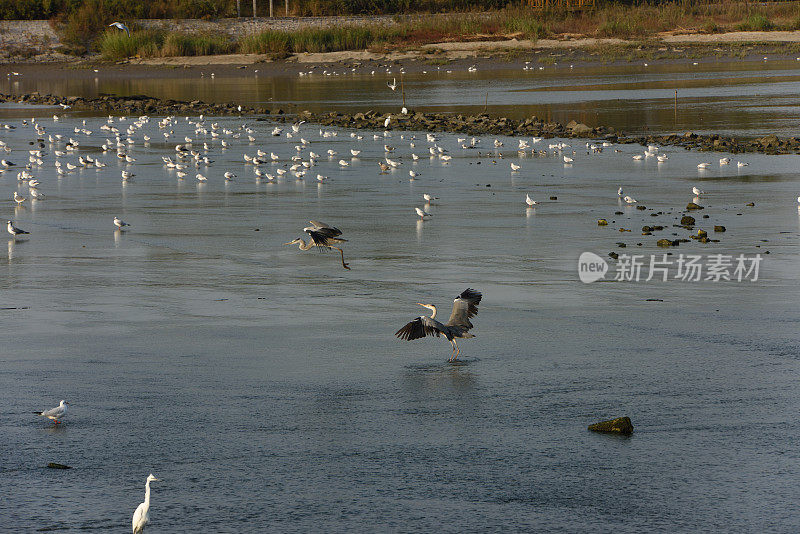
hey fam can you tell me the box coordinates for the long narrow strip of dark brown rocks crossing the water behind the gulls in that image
[0,92,800,154]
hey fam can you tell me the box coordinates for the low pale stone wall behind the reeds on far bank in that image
[0,15,396,60]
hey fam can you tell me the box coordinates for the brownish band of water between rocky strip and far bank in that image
[6,57,800,137]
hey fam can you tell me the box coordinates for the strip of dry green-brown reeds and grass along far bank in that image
[28,0,800,59]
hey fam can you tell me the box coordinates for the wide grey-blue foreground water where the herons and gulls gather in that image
[0,103,800,532]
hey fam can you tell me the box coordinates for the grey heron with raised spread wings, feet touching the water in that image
[395,288,482,362]
